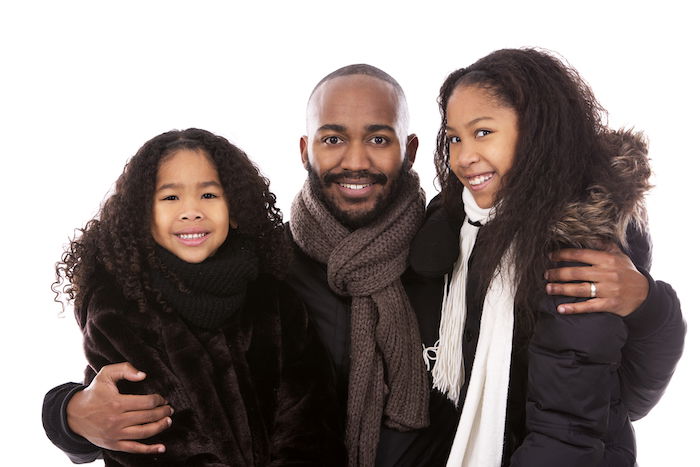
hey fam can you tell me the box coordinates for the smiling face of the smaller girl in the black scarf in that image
[151,149,231,263]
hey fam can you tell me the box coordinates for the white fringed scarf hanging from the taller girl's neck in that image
[433,188,515,467]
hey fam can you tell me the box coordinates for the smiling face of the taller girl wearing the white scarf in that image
[446,86,518,208]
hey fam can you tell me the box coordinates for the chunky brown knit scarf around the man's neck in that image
[290,171,429,467]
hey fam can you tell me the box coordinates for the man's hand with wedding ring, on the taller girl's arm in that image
[545,246,649,316]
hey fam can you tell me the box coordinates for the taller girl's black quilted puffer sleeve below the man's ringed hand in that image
[510,297,627,467]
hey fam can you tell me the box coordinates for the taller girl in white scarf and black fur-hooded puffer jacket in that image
[411,49,685,467]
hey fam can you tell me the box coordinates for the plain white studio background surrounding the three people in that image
[0,0,700,466]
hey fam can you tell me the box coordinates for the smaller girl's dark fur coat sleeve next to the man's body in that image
[270,284,347,466]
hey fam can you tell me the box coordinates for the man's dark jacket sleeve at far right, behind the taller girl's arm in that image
[620,270,686,420]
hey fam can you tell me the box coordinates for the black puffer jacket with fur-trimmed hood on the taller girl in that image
[410,133,685,467]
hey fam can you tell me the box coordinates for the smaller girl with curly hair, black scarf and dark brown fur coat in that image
[57,129,344,466]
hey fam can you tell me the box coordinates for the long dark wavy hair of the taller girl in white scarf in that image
[435,49,615,331]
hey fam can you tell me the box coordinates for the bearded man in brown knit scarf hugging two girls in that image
[43,65,671,466]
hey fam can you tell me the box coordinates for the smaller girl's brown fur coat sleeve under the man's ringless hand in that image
[83,294,230,466]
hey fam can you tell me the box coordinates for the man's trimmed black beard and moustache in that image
[306,158,409,230]
